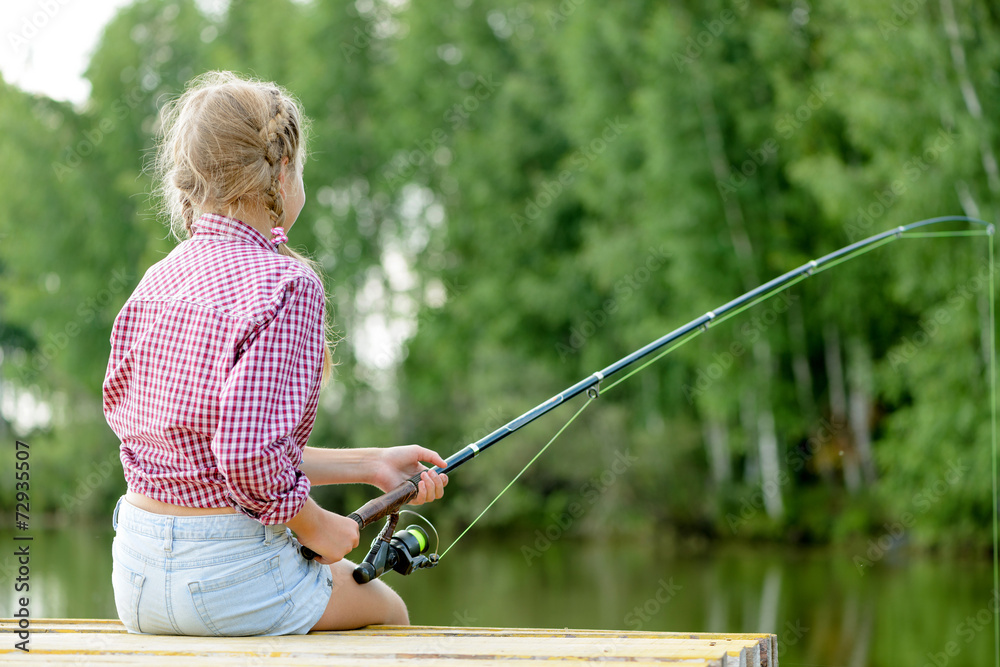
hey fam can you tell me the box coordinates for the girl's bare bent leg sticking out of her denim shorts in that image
[312,559,410,630]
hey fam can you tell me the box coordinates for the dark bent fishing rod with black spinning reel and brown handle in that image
[301,216,994,583]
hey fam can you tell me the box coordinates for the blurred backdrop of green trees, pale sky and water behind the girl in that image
[0,0,1000,667]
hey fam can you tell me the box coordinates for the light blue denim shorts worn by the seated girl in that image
[111,497,333,636]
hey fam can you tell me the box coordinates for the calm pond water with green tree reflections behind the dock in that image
[0,529,994,667]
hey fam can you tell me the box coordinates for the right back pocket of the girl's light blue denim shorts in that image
[188,556,293,636]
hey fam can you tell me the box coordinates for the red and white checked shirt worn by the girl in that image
[104,215,326,524]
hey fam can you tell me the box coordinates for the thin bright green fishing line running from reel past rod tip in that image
[428,222,1000,580]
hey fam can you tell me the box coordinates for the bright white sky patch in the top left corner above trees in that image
[0,0,160,103]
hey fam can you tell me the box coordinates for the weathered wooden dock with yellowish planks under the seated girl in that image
[0,618,778,667]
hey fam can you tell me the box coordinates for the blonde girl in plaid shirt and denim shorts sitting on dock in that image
[104,72,447,635]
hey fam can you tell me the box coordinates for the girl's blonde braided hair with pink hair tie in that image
[154,72,335,382]
